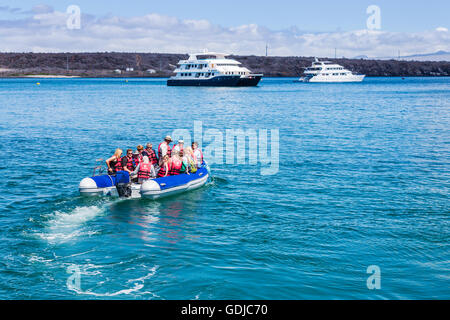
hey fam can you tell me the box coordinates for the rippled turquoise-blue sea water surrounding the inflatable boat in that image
[0,78,450,299]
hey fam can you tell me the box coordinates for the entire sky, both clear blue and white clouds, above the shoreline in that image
[0,0,450,57]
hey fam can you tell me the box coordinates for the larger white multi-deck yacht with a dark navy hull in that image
[167,52,263,87]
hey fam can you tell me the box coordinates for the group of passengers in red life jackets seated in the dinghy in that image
[106,136,203,183]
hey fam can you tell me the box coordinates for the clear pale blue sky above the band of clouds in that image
[0,0,450,32]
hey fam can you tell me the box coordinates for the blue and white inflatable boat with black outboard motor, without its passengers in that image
[79,165,209,199]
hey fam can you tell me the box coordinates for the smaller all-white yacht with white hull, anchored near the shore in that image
[299,58,365,82]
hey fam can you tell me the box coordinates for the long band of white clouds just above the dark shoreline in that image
[0,6,450,57]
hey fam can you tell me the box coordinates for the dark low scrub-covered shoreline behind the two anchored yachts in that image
[0,52,450,77]
